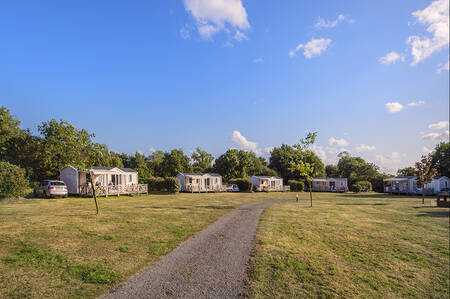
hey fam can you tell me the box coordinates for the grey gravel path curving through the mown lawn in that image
[103,200,286,298]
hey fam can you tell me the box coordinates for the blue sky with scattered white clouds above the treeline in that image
[0,0,449,172]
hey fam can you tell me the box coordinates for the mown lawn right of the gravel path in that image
[245,193,450,298]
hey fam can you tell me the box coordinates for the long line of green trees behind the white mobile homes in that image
[0,107,449,191]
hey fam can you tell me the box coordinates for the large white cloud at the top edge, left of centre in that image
[183,0,250,40]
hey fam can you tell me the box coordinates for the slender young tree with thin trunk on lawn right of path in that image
[289,132,323,207]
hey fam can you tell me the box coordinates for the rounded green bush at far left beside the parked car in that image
[0,162,28,198]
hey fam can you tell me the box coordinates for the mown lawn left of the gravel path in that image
[0,193,293,298]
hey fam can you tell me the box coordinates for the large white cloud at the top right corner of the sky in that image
[407,0,449,66]
